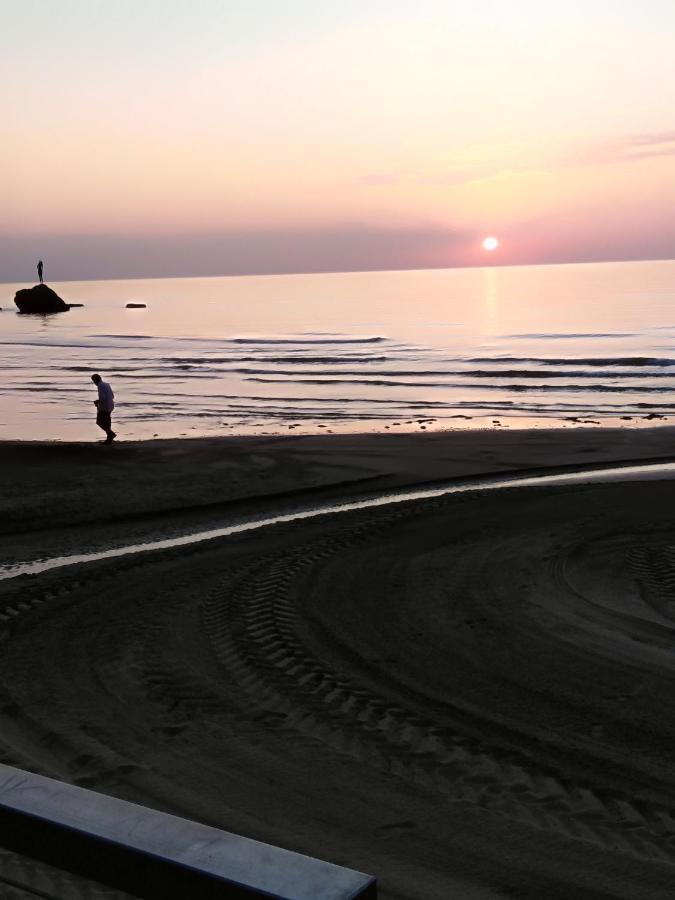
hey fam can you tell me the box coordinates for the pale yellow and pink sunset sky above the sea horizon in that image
[0,0,675,281]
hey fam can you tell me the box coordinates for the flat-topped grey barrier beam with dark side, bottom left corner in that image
[0,764,377,900]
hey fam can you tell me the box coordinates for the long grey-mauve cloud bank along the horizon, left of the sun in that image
[0,223,473,282]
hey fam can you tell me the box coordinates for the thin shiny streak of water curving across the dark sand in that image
[0,463,675,580]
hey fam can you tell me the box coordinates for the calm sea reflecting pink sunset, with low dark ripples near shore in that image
[0,262,675,440]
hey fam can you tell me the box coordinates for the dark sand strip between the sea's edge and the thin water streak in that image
[0,425,675,535]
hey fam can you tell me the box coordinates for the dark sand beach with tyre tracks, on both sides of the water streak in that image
[0,427,675,900]
